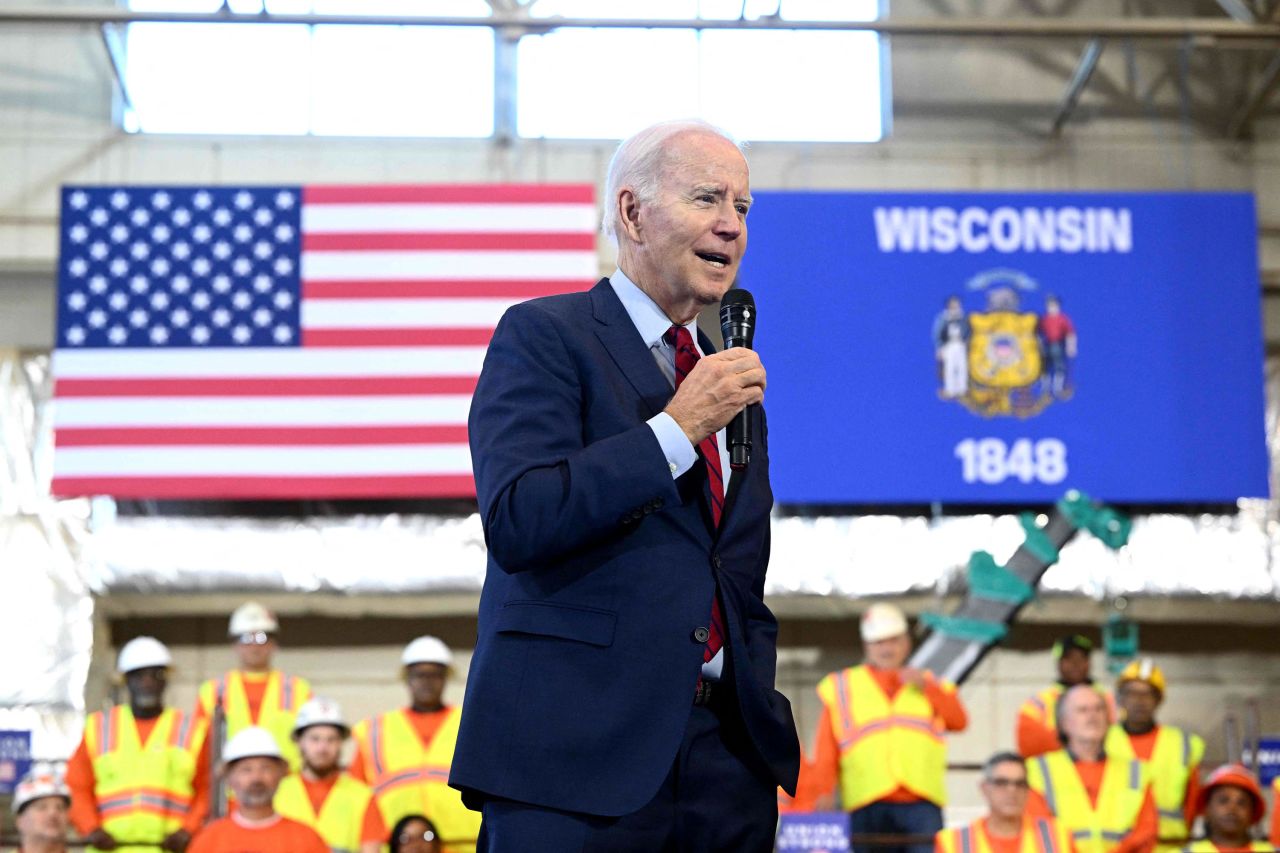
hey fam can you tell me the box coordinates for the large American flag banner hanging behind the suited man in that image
[52,184,598,500]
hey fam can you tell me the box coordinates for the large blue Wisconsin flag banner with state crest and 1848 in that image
[741,192,1267,503]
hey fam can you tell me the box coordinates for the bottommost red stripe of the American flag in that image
[52,474,476,500]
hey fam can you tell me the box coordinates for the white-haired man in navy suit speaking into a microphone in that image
[449,122,799,853]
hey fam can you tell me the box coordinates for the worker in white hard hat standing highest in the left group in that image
[196,601,311,770]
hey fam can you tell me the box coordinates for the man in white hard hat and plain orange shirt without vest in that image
[189,726,330,853]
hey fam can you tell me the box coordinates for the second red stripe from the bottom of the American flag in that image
[54,424,467,447]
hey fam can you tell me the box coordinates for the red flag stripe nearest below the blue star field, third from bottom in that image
[54,377,476,397]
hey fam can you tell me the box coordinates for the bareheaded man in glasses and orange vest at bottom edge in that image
[934,752,1075,853]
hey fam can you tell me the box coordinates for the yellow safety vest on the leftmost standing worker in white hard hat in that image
[84,706,205,853]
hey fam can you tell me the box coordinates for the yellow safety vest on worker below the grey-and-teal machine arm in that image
[818,665,947,811]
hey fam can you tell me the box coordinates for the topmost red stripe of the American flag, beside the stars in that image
[302,183,595,205]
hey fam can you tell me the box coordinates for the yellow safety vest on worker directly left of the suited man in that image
[351,708,480,853]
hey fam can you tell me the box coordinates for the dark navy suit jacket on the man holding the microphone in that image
[449,279,799,816]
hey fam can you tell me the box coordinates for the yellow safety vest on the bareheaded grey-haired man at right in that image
[1027,749,1151,853]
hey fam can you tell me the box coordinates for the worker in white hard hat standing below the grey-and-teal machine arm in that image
[810,603,969,853]
